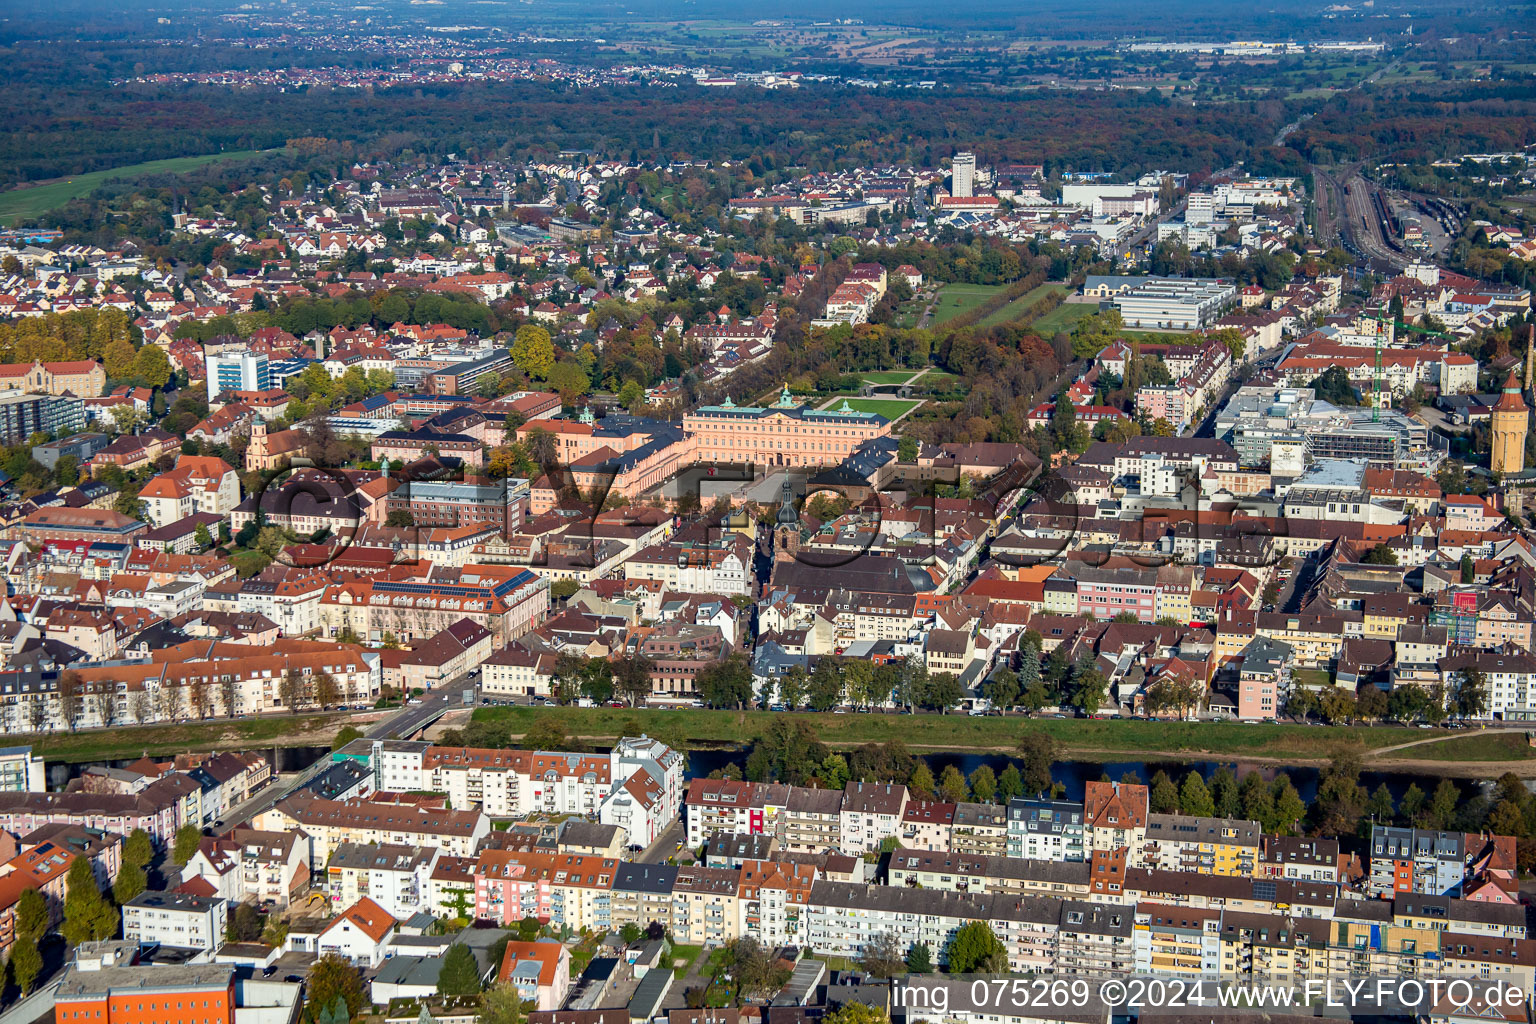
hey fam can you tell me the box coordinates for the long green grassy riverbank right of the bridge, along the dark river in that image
[475,708,1510,761]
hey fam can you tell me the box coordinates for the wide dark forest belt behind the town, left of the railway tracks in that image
[0,81,1286,181]
